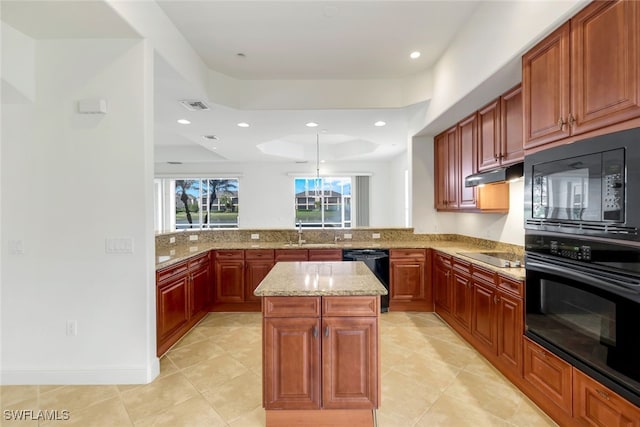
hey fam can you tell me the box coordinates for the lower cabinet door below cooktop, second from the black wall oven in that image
[471,280,497,354]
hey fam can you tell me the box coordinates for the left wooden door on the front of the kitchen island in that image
[263,317,321,409]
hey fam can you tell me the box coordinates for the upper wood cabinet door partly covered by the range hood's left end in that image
[458,113,478,209]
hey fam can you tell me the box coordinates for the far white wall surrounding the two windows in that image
[155,161,406,228]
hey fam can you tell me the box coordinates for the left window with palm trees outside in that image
[156,178,239,230]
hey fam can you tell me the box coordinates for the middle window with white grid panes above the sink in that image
[294,177,351,228]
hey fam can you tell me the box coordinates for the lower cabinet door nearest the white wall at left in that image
[156,274,190,347]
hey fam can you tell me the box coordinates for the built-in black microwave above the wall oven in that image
[524,128,640,241]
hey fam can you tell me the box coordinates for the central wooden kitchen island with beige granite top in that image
[255,261,387,427]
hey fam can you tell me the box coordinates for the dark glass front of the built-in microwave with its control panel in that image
[532,149,624,222]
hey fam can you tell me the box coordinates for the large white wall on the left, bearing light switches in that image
[0,39,159,384]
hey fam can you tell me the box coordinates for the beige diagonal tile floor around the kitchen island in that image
[0,312,555,427]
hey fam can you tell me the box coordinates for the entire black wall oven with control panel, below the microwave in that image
[525,236,640,406]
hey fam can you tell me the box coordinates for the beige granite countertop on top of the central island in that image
[254,261,387,297]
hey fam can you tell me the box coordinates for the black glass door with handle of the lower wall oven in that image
[526,255,640,402]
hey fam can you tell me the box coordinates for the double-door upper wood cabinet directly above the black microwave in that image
[522,0,640,149]
